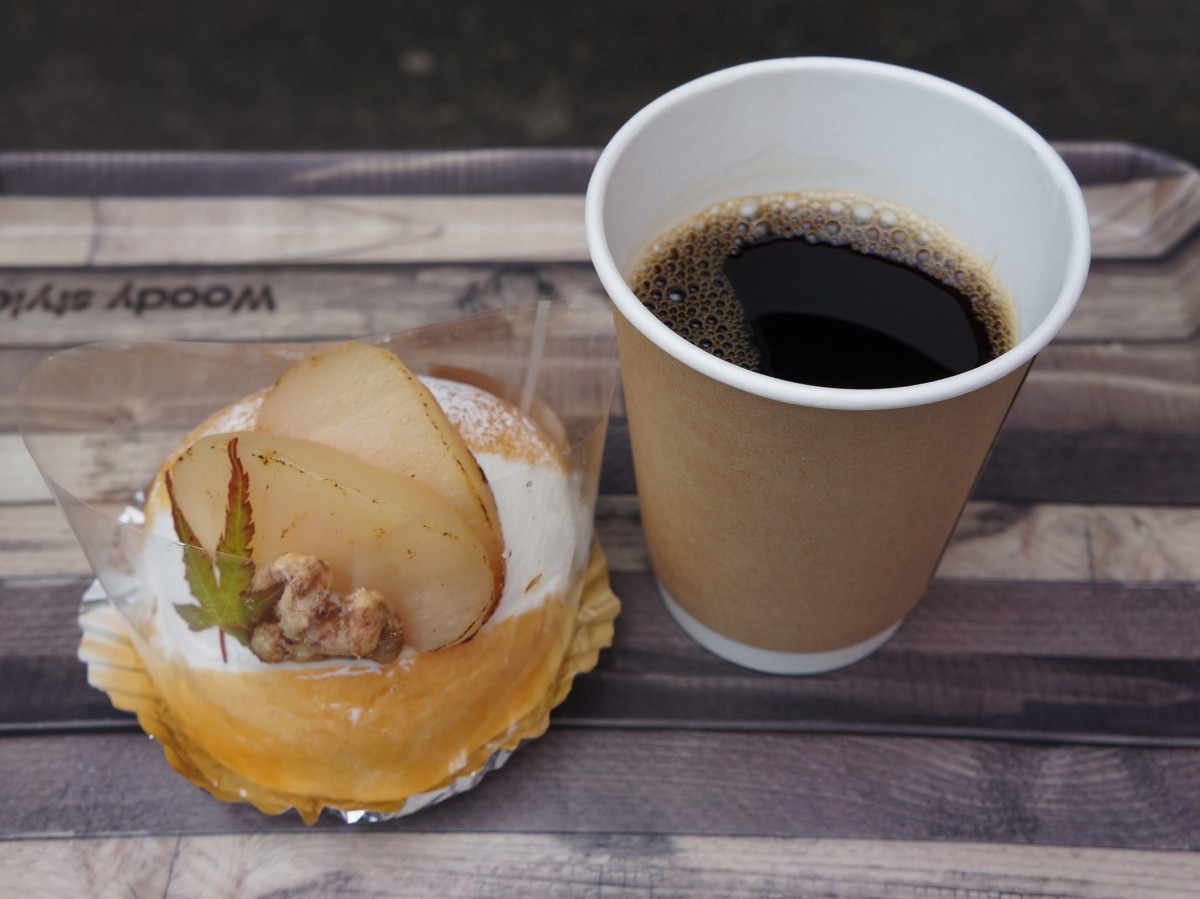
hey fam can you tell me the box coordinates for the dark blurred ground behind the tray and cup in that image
[0,0,1200,163]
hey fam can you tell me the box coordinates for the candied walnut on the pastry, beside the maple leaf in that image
[250,552,403,663]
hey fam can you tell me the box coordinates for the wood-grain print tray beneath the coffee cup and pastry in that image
[0,144,1200,897]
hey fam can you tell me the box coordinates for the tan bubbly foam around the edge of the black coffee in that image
[629,190,1016,371]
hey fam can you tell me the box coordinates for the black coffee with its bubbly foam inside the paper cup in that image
[630,191,1015,388]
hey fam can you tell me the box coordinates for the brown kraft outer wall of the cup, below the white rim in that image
[616,313,1028,653]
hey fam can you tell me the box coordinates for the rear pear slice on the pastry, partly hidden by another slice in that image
[256,343,504,587]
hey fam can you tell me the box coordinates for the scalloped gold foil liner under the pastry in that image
[79,539,620,825]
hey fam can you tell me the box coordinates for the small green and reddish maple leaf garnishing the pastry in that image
[166,437,284,661]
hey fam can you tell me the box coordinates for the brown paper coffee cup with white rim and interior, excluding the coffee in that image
[586,58,1090,673]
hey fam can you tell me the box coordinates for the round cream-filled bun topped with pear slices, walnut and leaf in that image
[100,343,616,821]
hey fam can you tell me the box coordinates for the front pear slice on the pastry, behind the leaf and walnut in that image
[172,431,498,652]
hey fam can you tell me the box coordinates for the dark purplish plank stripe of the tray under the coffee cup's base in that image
[0,573,1200,748]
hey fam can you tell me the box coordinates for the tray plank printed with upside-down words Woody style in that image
[0,250,1200,346]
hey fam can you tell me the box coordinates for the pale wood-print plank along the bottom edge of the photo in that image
[0,833,1200,899]
